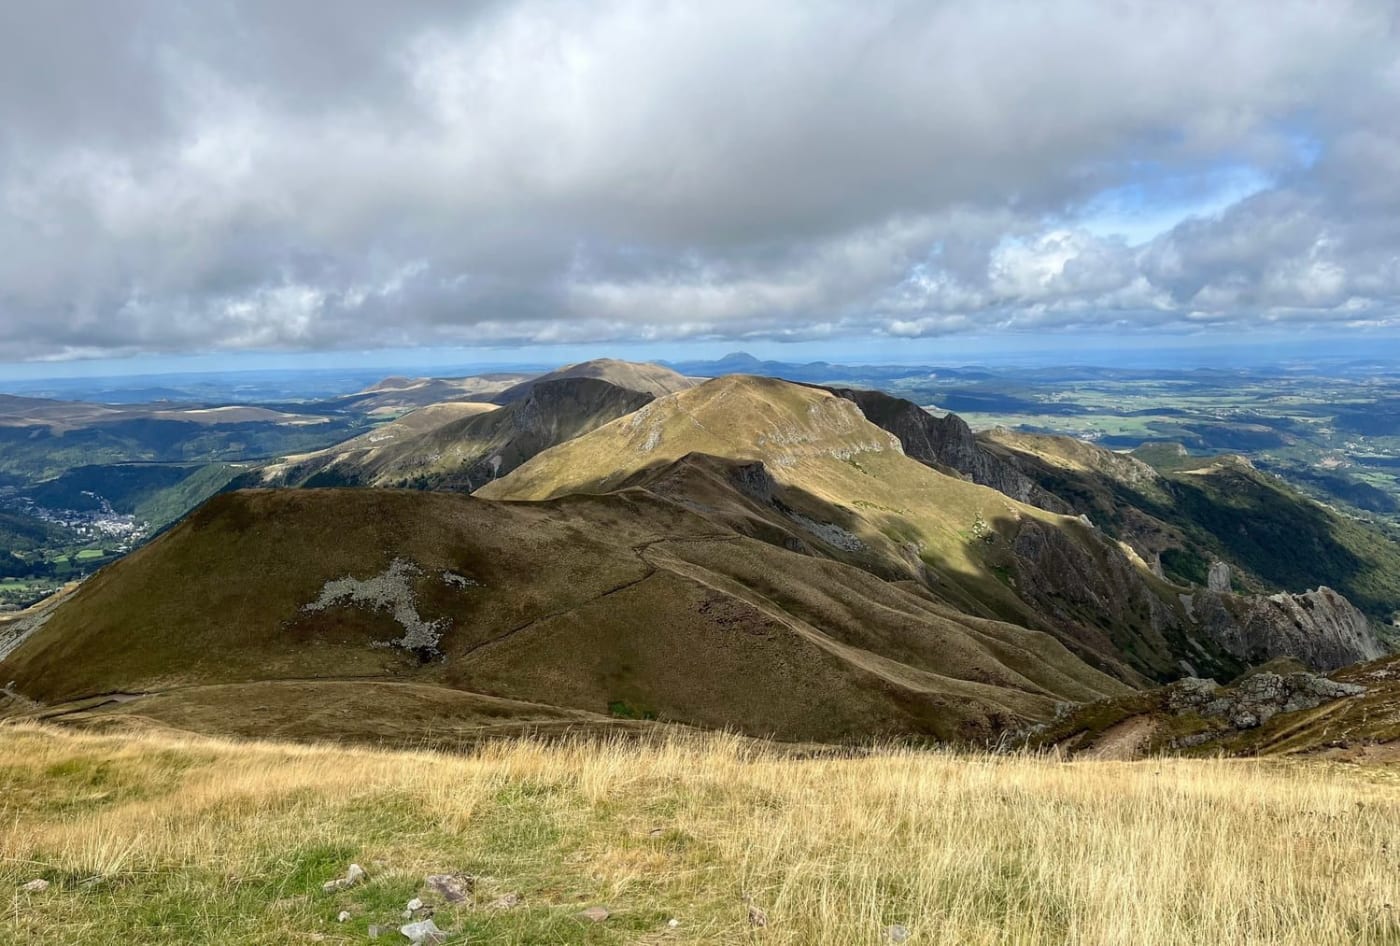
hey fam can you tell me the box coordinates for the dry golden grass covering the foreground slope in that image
[0,726,1400,946]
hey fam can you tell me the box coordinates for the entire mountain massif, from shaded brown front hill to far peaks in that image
[0,355,1400,742]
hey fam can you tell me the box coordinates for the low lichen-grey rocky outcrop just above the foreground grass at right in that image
[1166,673,1366,736]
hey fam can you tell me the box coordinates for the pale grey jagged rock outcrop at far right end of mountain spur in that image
[1187,588,1386,670]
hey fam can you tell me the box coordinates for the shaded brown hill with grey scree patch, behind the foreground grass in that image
[0,490,1126,740]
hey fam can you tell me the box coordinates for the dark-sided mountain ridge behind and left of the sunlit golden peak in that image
[259,376,652,493]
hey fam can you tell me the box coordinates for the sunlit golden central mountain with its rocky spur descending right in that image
[479,375,1379,684]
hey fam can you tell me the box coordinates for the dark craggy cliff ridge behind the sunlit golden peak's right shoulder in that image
[827,388,1070,512]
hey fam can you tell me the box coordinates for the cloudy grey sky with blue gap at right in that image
[0,0,1400,375]
